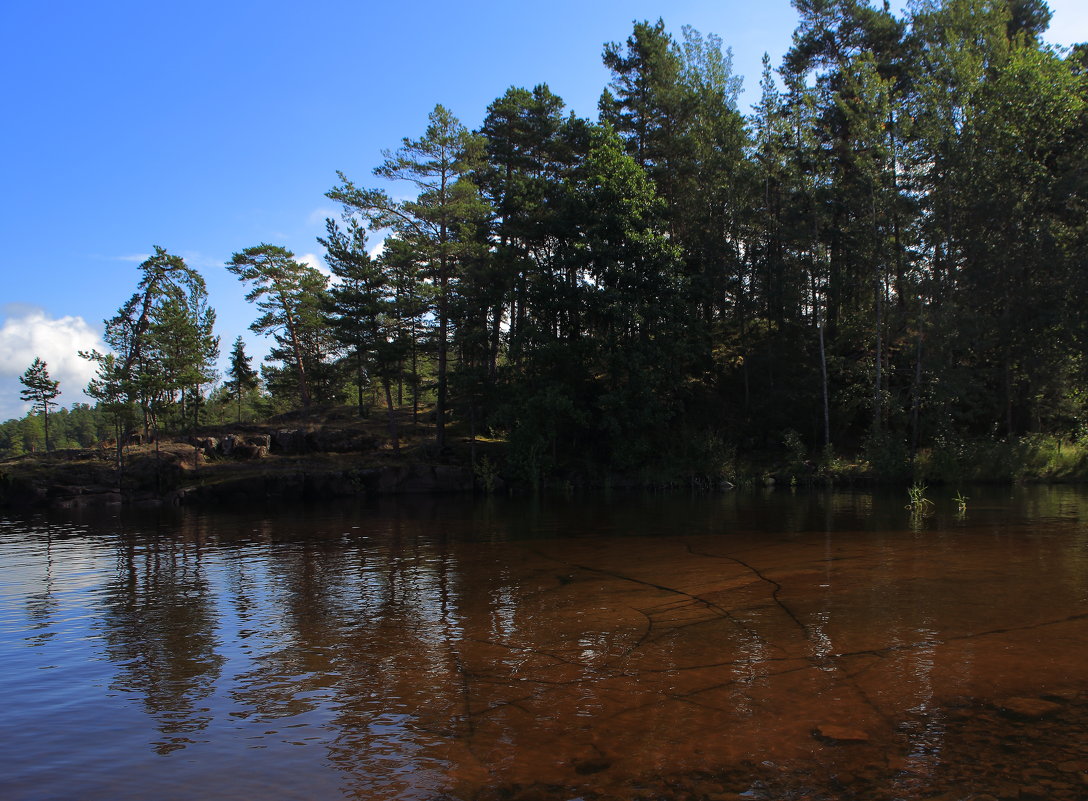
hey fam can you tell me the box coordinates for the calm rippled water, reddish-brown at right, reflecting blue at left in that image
[0,488,1088,801]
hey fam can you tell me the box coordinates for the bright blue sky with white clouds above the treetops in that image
[0,0,1088,420]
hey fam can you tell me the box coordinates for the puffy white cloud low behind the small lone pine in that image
[0,304,107,420]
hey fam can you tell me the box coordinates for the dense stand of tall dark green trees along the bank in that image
[0,0,1088,480]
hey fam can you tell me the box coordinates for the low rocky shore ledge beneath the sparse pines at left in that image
[0,428,485,508]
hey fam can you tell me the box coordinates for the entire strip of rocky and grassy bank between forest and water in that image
[0,406,1088,508]
